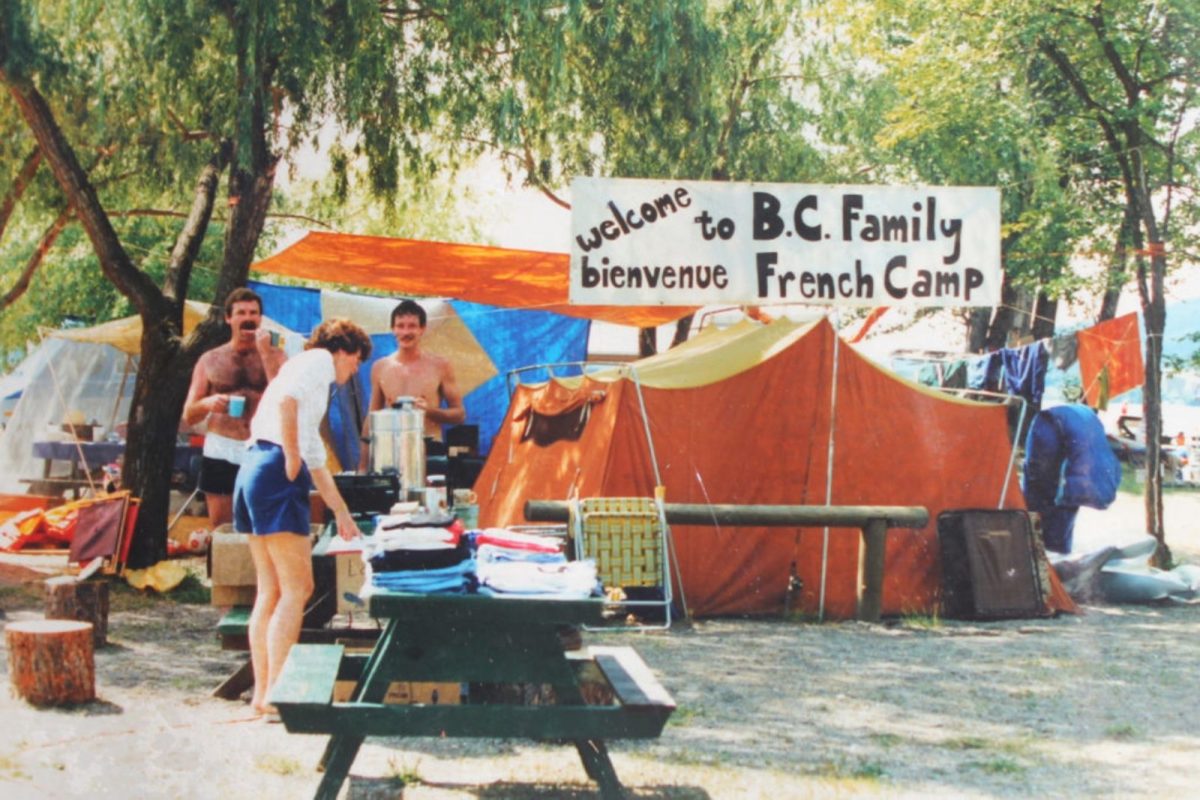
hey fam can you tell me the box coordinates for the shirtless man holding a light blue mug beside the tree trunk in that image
[184,288,287,528]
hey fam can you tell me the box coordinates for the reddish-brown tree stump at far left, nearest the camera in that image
[4,619,96,705]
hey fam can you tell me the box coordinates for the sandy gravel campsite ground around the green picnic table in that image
[0,494,1200,800]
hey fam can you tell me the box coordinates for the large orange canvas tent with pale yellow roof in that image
[475,319,1073,619]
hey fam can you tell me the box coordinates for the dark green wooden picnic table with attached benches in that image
[268,591,676,800]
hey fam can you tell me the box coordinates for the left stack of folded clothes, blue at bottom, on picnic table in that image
[362,512,475,594]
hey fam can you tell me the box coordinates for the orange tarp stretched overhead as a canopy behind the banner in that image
[253,231,695,327]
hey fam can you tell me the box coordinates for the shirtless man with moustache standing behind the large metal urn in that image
[359,300,467,471]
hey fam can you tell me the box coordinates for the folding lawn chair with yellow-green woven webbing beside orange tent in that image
[570,498,672,630]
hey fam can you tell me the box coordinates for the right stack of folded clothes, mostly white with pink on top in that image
[473,529,602,600]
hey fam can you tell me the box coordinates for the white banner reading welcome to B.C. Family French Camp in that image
[570,178,1001,306]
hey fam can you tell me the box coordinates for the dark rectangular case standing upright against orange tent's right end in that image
[937,509,1044,620]
